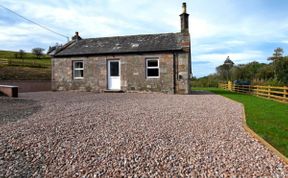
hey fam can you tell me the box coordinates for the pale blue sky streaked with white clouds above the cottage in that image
[0,0,288,77]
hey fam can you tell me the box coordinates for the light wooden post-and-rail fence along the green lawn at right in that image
[218,82,288,103]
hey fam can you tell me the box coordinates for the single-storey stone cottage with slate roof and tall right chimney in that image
[52,3,191,94]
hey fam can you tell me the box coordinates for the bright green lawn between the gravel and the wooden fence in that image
[193,88,288,157]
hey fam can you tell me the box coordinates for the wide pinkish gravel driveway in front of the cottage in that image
[0,92,288,177]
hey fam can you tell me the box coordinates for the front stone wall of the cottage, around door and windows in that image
[52,53,173,93]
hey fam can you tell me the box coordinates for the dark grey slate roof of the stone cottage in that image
[55,33,182,57]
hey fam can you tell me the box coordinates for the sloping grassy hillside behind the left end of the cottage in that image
[0,51,51,80]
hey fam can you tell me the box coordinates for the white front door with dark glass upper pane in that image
[108,60,121,90]
